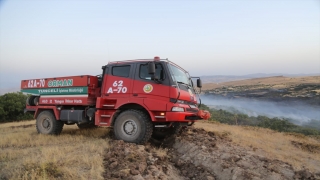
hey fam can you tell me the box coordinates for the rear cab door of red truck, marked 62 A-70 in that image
[102,64,134,98]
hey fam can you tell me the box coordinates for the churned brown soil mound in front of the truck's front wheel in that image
[104,127,320,180]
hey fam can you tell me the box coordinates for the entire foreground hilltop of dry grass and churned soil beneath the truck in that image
[0,120,320,180]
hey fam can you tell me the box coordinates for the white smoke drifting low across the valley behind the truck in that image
[201,95,320,125]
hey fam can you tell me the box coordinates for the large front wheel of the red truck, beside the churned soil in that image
[113,110,153,144]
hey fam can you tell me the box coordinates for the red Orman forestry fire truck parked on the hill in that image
[21,57,210,144]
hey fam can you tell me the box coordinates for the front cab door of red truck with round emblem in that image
[132,62,169,111]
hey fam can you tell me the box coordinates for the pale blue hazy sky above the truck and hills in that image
[0,0,320,88]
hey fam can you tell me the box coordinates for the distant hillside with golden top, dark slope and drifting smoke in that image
[202,76,320,126]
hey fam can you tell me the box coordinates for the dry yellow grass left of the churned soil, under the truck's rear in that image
[0,121,108,179]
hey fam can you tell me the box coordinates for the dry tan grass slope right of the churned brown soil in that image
[195,122,320,172]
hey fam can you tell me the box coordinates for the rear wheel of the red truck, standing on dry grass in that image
[36,111,64,135]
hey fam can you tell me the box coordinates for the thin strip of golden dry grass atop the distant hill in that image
[202,76,320,90]
